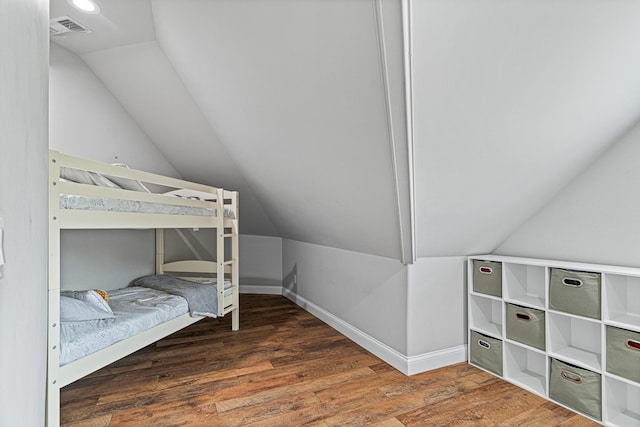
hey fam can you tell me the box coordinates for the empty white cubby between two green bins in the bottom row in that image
[504,342,548,397]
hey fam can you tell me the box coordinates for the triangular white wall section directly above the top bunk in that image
[49,44,180,178]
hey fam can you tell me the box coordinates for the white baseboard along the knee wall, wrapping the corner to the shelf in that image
[282,288,467,375]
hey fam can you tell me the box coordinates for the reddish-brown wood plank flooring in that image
[61,295,597,427]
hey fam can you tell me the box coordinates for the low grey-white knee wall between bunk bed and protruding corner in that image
[282,239,407,355]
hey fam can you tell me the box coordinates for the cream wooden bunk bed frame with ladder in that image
[46,150,239,427]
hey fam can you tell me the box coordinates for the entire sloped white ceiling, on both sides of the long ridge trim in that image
[51,0,640,260]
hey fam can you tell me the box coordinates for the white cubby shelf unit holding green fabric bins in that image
[467,255,640,427]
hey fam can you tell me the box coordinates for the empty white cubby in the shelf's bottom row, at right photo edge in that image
[605,376,640,427]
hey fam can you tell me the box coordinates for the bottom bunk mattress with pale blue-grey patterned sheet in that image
[60,286,189,366]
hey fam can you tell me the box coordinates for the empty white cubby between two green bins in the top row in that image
[503,262,546,309]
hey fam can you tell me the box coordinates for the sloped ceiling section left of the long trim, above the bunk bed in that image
[51,0,403,258]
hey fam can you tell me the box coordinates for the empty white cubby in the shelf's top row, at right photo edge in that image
[604,274,640,331]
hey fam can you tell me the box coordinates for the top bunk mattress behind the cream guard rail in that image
[60,194,234,218]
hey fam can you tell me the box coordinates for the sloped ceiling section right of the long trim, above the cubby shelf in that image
[412,0,640,256]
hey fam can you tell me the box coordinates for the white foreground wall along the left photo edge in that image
[0,0,49,426]
